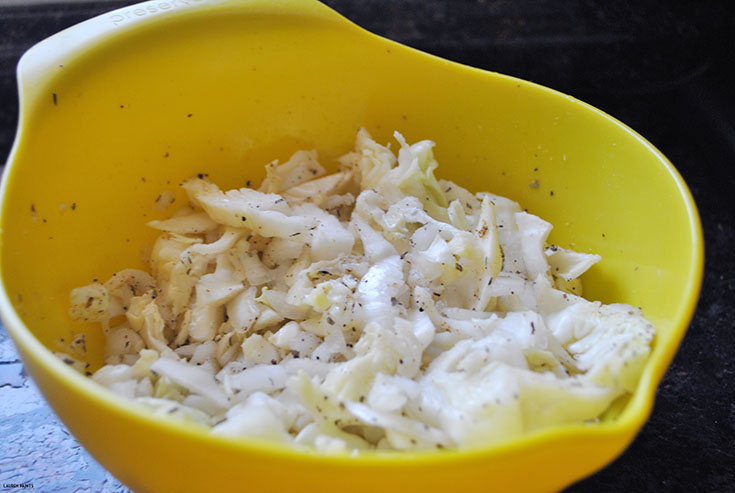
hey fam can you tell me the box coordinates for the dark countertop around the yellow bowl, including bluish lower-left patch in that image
[0,0,735,492]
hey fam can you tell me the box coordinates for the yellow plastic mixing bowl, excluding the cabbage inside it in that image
[0,0,703,491]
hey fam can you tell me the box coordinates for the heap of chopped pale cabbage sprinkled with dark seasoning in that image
[66,129,655,453]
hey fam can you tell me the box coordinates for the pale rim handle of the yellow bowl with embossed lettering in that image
[17,0,357,108]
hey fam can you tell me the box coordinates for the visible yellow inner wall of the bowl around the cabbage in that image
[0,1,702,490]
